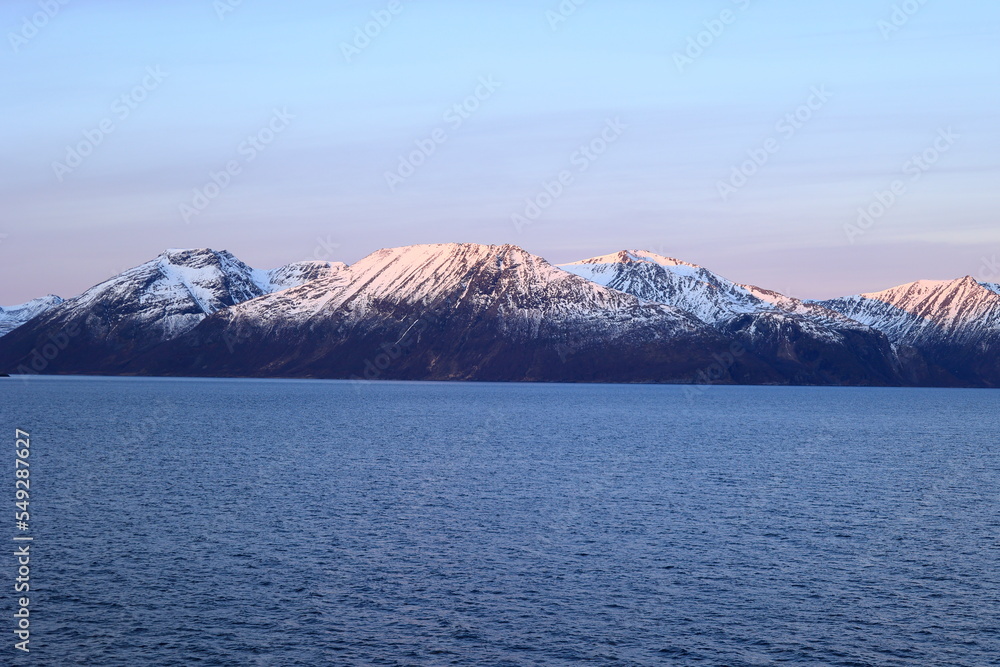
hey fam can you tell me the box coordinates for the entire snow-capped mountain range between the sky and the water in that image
[0,243,1000,387]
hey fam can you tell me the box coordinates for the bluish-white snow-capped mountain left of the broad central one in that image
[2,248,344,372]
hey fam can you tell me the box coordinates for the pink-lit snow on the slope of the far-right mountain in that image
[819,276,1000,345]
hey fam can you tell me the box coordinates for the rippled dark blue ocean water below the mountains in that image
[0,378,1000,666]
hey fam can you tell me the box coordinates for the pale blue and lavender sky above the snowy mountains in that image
[0,0,1000,304]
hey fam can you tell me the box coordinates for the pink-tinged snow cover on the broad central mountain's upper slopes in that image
[231,243,701,332]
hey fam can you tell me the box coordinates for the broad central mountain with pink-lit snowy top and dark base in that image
[125,243,766,381]
